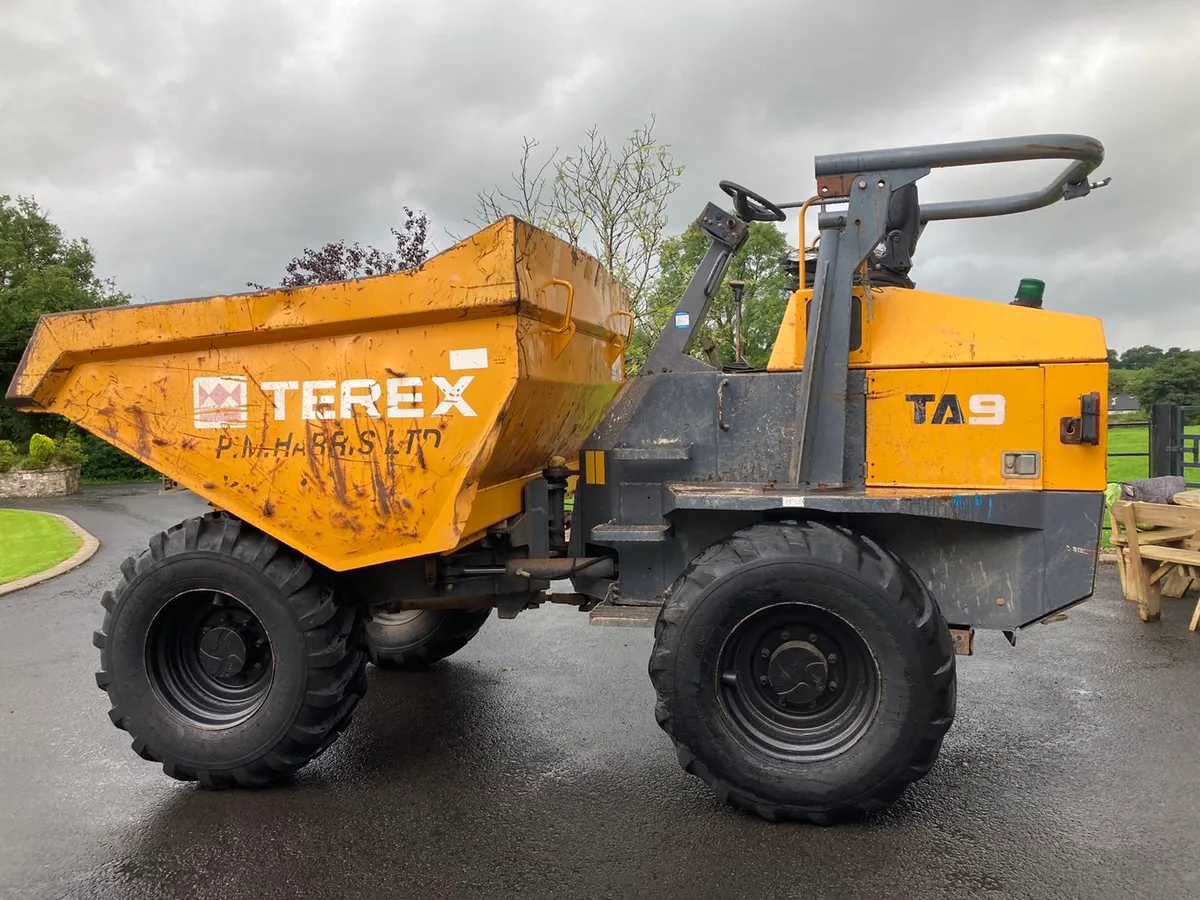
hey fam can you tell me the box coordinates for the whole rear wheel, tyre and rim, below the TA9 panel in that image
[649,522,955,824]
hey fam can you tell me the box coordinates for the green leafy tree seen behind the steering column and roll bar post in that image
[629,222,788,371]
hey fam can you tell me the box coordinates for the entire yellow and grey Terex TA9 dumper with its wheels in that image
[7,134,1108,823]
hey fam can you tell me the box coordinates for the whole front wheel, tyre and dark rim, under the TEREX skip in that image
[94,512,367,787]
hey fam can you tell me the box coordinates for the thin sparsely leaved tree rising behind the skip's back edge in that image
[475,115,683,336]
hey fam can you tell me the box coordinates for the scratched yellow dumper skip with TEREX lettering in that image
[7,218,632,571]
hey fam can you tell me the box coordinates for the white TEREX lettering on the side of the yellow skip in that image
[260,376,476,421]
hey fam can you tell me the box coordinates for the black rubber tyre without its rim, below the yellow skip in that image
[92,512,367,788]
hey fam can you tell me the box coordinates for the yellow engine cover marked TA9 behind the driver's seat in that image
[769,288,1108,491]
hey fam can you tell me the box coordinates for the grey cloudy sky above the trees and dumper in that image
[0,0,1200,349]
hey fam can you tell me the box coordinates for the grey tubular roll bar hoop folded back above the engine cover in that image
[816,134,1106,222]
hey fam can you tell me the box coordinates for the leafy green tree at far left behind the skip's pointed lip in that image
[0,194,152,478]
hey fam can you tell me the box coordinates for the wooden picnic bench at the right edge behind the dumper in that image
[1109,500,1200,631]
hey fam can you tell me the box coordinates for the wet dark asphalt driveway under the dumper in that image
[0,486,1200,900]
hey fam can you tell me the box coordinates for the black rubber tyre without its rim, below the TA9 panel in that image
[649,522,956,824]
